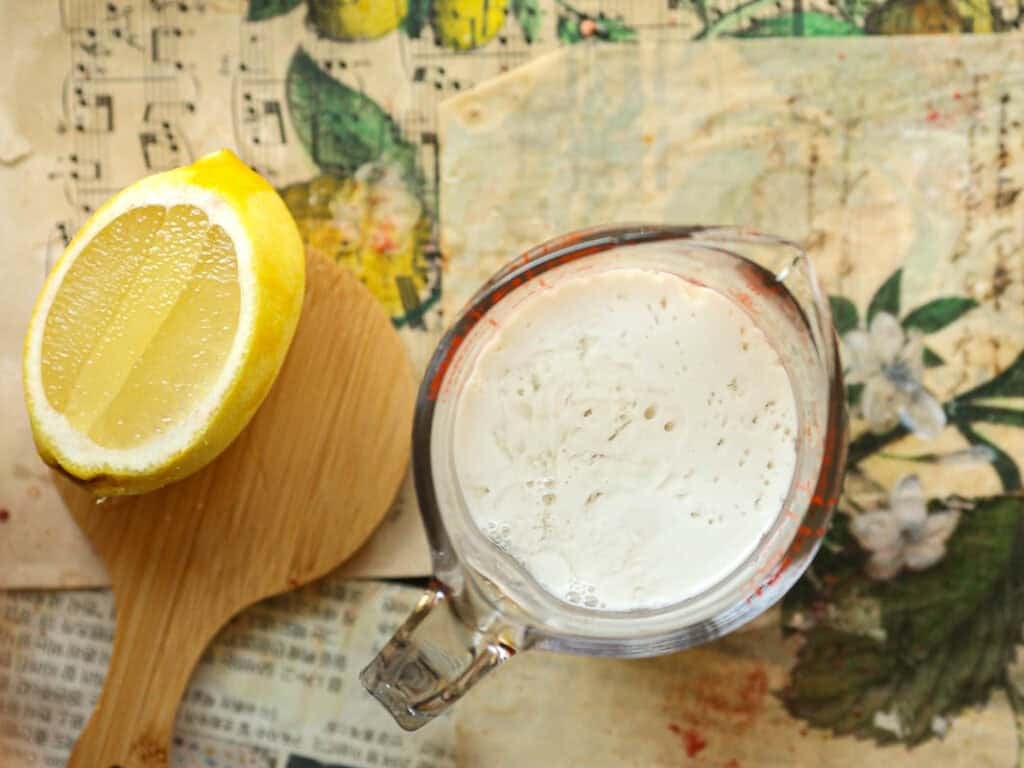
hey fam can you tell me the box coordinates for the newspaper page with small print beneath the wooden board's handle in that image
[0,579,456,768]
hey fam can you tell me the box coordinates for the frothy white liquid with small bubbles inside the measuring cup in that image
[454,268,797,611]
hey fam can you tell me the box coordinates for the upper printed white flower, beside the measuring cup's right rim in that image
[843,312,946,438]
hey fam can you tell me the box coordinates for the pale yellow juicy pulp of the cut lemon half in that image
[41,205,240,449]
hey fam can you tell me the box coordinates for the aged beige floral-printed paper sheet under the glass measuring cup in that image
[440,38,1024,766]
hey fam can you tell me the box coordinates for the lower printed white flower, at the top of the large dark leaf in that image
[850,475,959,581]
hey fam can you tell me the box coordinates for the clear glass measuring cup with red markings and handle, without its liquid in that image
[360,225,847,730]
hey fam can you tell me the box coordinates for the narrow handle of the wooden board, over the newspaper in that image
[68,585,228,768]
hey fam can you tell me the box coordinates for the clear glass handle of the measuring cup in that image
[359,581,515,731]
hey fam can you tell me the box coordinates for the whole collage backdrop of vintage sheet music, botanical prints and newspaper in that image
[0,0,1024,768]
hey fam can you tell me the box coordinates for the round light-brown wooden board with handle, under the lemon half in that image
[59,257,415,768]
